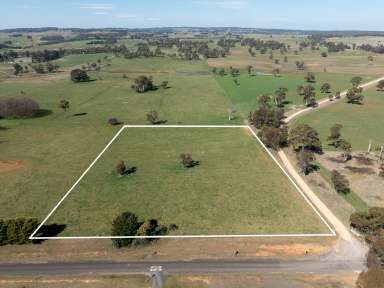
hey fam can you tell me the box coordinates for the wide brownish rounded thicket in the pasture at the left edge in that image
[0,97,40,119]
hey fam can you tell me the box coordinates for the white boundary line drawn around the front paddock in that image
[29,125,336,240]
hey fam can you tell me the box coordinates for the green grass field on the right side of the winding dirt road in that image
[296,89,384,151]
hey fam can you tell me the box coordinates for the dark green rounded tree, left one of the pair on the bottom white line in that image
[111,212,140,248]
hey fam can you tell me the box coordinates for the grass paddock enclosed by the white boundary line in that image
[43,128,327,236]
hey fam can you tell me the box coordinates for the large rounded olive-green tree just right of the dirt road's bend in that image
[288,124,322,152]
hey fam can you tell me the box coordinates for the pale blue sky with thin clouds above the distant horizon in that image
[0,0,384,31]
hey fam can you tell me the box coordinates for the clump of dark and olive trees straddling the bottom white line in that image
[111,212,171,248]
